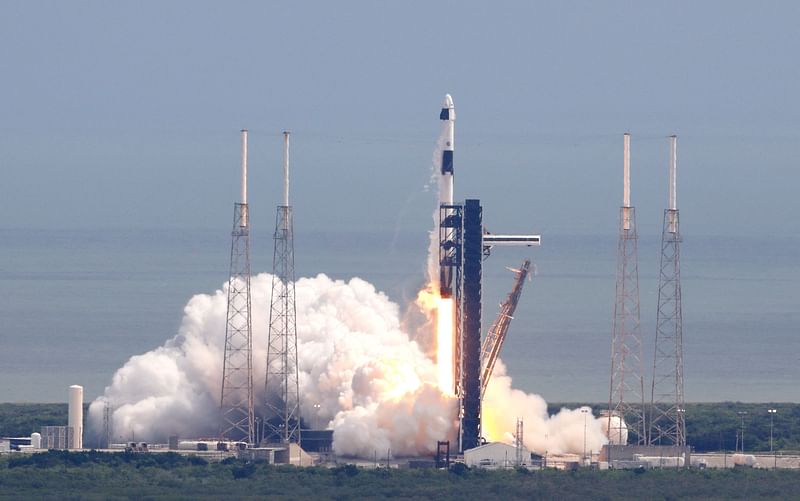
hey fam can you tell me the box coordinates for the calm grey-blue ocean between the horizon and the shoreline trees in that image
[0,228,800,403]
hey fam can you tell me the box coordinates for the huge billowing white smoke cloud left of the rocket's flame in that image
[87,274,456,457]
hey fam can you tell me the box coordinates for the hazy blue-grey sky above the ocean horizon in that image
[0,0,800,235]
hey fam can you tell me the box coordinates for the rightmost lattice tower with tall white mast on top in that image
[649,136,686,447]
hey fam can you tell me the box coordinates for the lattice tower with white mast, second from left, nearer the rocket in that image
[264,132,300,443]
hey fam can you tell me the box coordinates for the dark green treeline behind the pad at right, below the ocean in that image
[548,402,800,452]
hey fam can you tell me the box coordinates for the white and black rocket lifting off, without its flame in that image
[439,94,458,298]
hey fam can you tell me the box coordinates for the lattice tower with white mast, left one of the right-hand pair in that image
[608,134,647,445]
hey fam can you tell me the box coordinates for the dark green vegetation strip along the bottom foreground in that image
[0,451,800,500]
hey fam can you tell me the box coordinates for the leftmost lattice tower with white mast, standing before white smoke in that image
[220,130,255,444]
